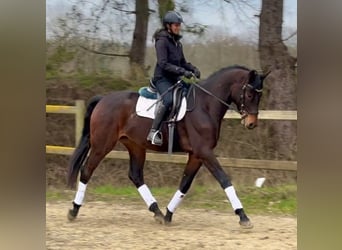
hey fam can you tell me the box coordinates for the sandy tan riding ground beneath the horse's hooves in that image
[46,201,297,250]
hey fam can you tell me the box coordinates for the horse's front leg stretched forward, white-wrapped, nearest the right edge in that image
[201,150,253,228]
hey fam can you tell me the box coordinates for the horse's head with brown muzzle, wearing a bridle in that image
[232,70,270,129]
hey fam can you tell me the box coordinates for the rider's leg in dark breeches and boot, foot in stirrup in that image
[147,78,172,145]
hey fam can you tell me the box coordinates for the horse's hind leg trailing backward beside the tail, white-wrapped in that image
[68,149,110,220]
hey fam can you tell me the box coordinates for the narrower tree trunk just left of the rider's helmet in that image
[129,0,149,79]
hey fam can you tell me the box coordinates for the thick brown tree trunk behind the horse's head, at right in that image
[259,0,297,159]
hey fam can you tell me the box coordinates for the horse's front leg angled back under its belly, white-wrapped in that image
[165,154,202,224]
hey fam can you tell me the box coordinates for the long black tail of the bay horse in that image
[67,96,102,188]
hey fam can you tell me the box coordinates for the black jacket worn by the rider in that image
[154,30,196,82]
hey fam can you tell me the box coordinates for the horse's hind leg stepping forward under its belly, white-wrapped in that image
[121,139,164,223]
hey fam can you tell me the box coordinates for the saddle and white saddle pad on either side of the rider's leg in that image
[136,80,191,154]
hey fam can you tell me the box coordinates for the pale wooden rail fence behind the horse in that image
[45,100,297,171]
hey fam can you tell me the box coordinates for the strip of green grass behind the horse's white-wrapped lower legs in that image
[46,185,297,215]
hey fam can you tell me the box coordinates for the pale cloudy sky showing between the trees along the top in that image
[46,0,297,44]
